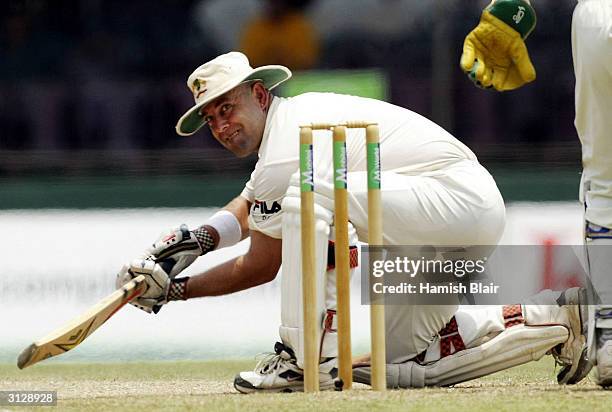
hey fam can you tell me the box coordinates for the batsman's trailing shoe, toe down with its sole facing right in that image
[551,288,593,385]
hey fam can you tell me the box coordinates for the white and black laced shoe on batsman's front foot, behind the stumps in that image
[234,342,338,393]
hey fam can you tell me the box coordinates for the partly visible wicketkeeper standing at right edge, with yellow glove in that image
[460,0,612,387]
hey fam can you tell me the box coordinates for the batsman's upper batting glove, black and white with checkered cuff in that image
[140,225,214,279]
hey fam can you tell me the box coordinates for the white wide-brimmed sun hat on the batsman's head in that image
[176,52,291,136]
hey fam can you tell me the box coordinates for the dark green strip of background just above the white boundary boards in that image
[0,166,580,209]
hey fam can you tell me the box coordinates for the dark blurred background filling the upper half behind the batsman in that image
[0,0,581,209]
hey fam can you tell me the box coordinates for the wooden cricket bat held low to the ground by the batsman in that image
[17,275,146,369]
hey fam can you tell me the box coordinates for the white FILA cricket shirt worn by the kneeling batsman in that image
[241,93,476,239]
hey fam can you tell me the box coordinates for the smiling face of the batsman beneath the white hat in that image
[201,83,270,157]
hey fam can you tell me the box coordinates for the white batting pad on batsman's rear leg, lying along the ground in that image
[354,296,570,388]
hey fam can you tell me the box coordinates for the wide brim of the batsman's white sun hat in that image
[176,65,291,136]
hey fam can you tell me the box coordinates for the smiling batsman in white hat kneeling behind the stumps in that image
[117,52,586,393]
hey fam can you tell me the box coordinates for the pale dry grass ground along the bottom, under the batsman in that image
[0,357,612,412]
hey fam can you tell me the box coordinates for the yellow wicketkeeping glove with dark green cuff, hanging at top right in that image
[461,0,536,91]
